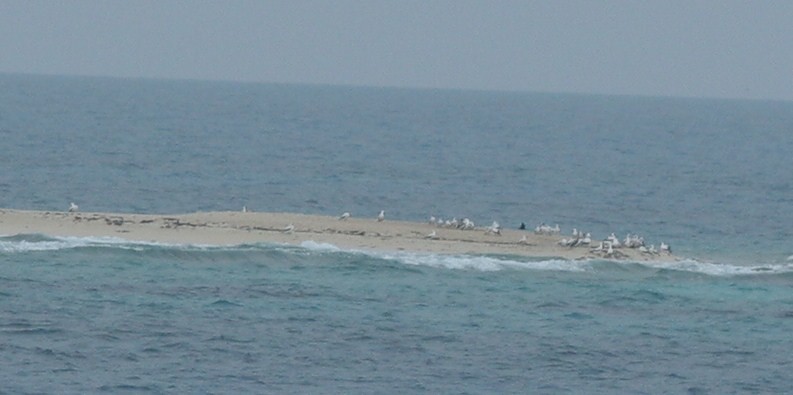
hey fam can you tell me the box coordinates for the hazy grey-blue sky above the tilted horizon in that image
[0,0,793,100]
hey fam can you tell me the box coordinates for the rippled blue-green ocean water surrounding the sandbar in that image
[0,74,793,394]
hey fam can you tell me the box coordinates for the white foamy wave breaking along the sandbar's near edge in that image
[0,234,793,277]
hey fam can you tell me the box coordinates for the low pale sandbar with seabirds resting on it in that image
[0,209,678,261]
